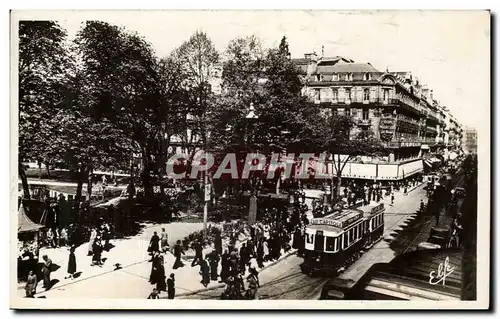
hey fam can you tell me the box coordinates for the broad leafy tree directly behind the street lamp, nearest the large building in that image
[211,36,322,196]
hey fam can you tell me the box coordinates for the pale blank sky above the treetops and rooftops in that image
[18,11,490,127]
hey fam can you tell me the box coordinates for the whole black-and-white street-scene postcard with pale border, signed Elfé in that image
[9,10,491,310]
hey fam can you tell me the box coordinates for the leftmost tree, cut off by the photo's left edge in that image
[18,21,71,198]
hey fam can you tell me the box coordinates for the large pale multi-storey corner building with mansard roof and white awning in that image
[294,53,462,180]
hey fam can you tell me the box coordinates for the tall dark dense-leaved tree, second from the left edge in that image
[76,21,165,195]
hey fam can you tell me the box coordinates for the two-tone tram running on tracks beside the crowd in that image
[300,204,385,275]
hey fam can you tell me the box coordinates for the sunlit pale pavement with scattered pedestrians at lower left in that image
[23,223,203,298]
